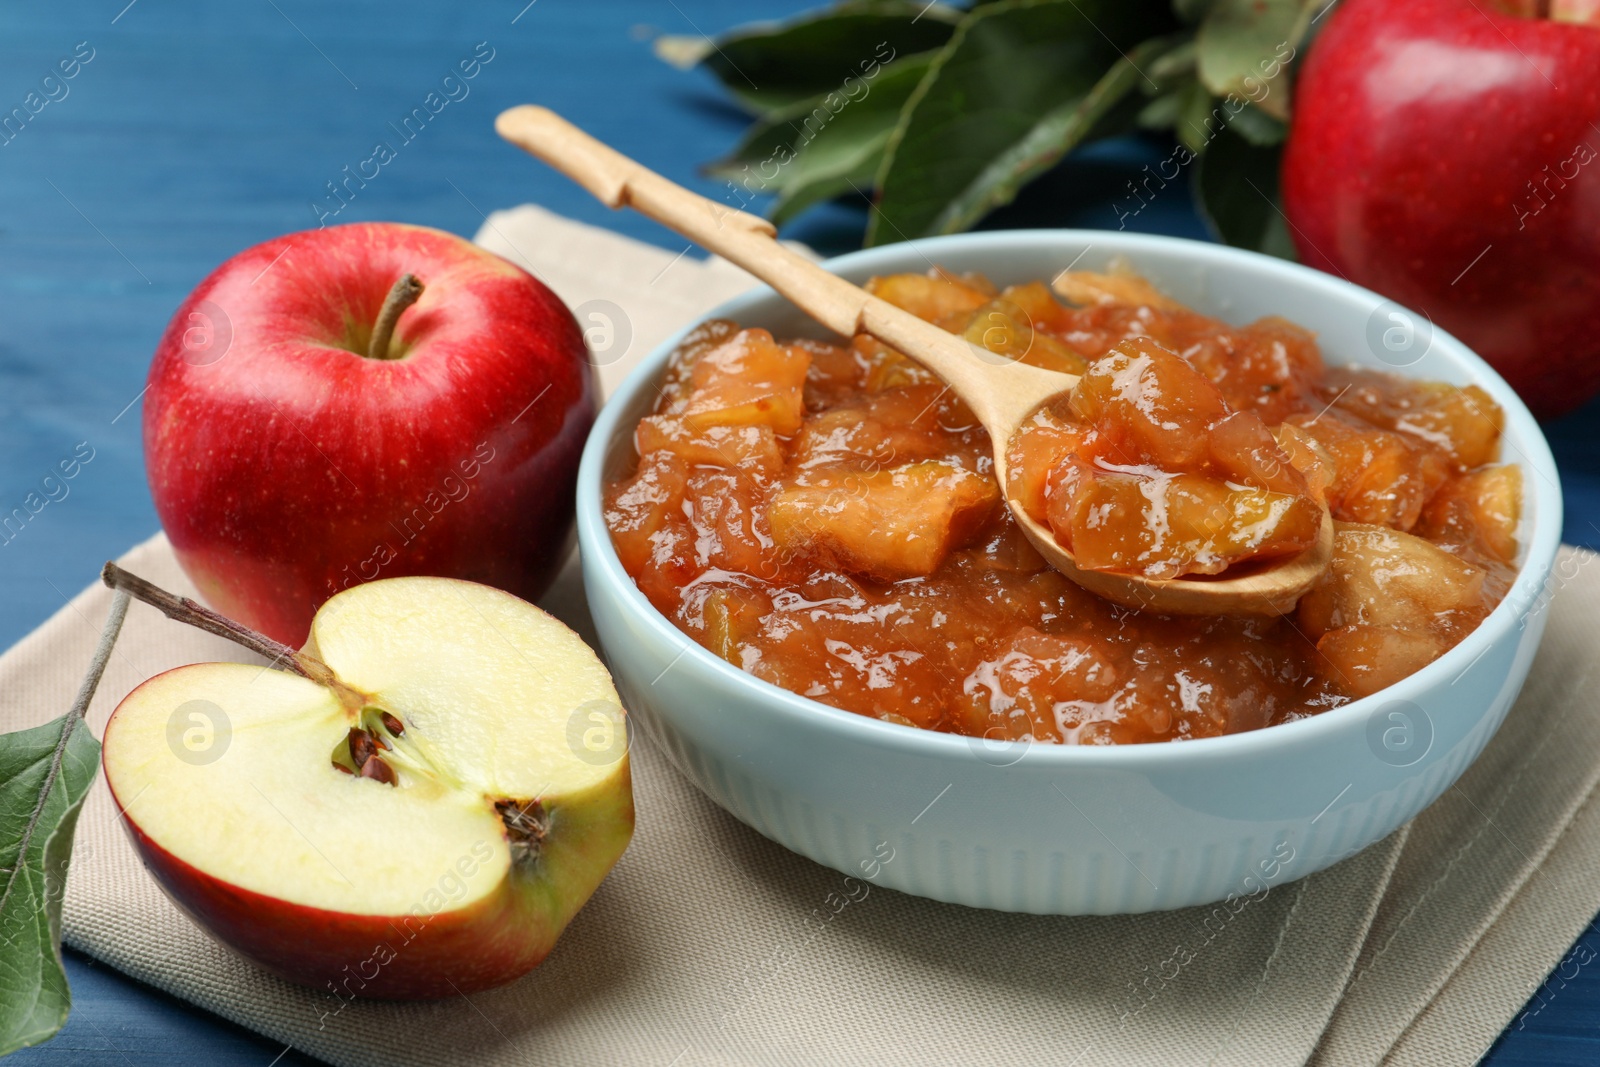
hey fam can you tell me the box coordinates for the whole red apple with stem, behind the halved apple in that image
[144,222,597,646]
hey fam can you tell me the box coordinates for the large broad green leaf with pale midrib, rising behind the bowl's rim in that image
[866,0,1171,245]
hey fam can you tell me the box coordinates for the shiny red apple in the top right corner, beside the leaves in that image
[1283,0,1600,418]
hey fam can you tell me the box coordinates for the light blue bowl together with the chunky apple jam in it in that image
[579,230,1560,913]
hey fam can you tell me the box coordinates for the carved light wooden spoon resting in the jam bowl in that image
[494,104,1333,614]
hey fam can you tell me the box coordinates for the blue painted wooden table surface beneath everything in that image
[0,0,1600,1067]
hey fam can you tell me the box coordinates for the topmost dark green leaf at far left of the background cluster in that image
[654,0,962,117]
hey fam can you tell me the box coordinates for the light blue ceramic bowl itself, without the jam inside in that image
[578,230,1562,915]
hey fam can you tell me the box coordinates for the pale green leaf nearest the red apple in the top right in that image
[1195,0,1325,120]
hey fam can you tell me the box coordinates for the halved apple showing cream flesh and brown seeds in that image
[102,577,634,1000]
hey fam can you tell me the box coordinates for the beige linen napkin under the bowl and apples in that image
[0,208,1600,1067]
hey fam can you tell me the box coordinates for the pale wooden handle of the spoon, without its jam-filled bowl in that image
[494,104,1056,437]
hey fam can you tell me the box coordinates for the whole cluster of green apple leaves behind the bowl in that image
[675,0,1312,247]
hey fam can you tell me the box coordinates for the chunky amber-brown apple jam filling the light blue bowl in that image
[605,270,1522,744]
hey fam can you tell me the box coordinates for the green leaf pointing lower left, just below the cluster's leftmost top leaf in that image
[707,54,933,224]
